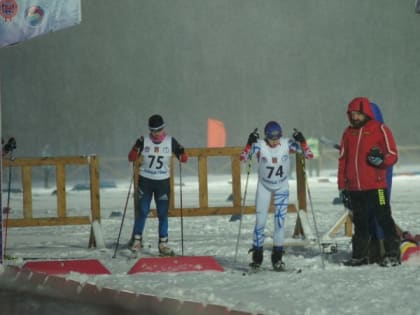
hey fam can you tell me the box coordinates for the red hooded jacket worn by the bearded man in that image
[338,97,398,191]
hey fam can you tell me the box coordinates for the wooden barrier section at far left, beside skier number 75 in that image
[3,155,101,246]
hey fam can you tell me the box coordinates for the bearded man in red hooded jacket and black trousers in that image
[338,97,400,266]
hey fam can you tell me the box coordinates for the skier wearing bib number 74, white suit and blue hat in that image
[241,121,313,271]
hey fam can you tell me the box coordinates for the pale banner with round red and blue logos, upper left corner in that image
[0,0,82,48]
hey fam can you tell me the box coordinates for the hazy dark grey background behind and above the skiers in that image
[0,0,420,157]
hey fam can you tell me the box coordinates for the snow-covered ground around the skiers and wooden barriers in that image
[3,171,420,315]
